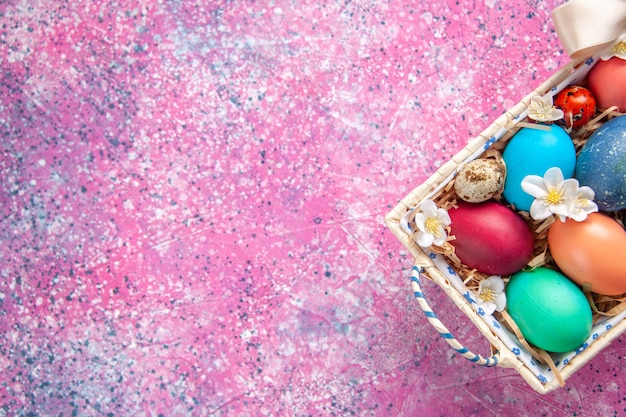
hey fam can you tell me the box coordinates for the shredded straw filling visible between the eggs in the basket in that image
[413,108,626,366]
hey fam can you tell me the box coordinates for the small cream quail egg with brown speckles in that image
[454,158,505,203]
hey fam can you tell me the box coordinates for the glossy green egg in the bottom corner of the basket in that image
[506,267,592,352]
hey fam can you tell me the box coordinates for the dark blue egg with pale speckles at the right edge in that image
[575,116,626,211]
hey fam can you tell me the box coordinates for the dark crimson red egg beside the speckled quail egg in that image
[448,201,534,275]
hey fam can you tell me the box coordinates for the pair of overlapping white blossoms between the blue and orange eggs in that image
[521,167,598,221]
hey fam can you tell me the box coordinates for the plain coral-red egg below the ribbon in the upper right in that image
[588,57,626,113]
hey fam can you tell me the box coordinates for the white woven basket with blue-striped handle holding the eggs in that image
[385,57,626,394]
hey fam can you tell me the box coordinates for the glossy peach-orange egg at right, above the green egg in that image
[548,213,626,295]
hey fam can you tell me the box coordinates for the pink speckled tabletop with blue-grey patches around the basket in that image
[0,0,626,416]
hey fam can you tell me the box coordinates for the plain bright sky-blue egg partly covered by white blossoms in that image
[502,124,576,211]
